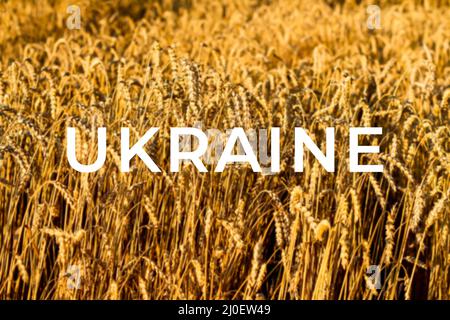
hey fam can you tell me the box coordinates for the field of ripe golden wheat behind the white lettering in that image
[0,0,450,300]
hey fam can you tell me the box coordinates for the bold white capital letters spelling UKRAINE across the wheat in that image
[67,127,383,173]
